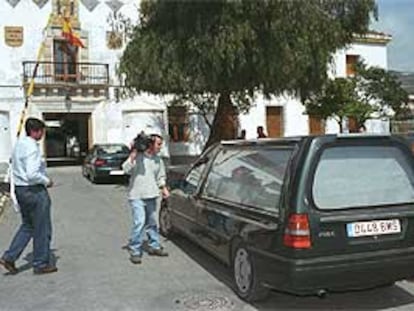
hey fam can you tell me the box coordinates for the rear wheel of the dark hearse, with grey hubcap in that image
[233,243,269,301]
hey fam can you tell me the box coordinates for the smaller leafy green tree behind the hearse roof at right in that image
[304,62,408,133]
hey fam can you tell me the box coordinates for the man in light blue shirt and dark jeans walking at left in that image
[0,118,57,274]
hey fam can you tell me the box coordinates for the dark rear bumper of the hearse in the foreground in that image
[253,247,414,295]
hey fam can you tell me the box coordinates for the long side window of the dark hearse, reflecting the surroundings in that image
[204,147,292,211]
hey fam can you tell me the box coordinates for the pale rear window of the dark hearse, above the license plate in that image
[312,146,414,210]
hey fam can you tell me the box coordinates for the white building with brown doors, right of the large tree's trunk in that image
[240,32,391,138]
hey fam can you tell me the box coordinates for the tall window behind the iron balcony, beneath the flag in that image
[53,40,78,82]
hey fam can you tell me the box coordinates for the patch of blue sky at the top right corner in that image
[371,0,414,73]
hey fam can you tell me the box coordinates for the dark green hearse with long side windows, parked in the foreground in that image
[160,134,414,301]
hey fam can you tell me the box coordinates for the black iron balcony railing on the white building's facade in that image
[23,61,109,86]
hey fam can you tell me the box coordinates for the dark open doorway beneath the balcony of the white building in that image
[43,113,91,160]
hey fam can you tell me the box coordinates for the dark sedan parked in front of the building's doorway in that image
[82,144,129,183]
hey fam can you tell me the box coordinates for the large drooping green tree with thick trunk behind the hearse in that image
[120,0,376,146]
